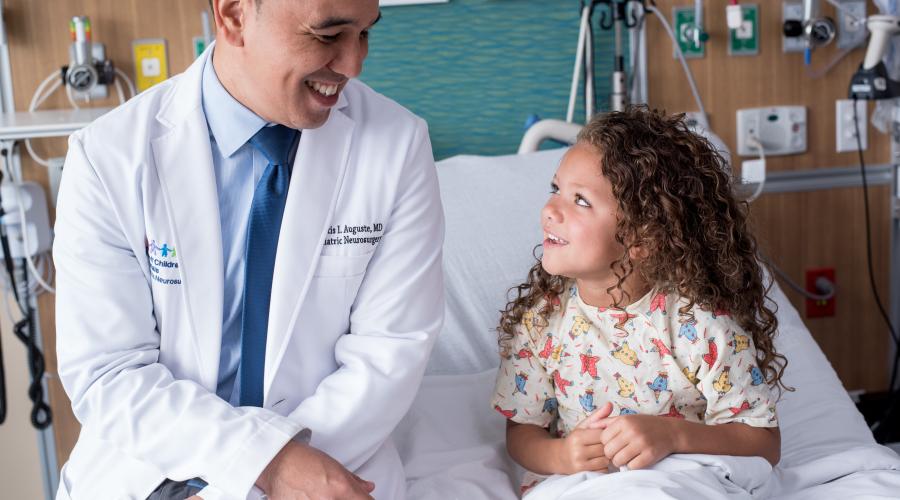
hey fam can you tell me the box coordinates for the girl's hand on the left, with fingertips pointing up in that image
[557,403,612,474]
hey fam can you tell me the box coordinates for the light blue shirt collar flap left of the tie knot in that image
[202,47,266,158]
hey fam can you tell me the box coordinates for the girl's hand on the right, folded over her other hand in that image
[592,415,677,469]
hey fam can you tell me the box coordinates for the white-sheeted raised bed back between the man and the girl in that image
[427,149,566,374]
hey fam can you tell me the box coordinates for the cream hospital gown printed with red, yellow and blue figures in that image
[492,284,778,494]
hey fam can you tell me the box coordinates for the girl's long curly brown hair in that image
[497,106,787,389]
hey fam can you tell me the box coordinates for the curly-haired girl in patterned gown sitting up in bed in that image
[492,107,786,492]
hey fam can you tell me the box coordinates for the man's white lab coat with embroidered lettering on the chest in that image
[53,46,443,500]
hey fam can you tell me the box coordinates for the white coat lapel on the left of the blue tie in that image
[151,50,224,391]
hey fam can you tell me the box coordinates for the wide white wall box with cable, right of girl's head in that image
[737,106,806,156]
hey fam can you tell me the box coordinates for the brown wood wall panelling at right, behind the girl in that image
[647,0,890,390]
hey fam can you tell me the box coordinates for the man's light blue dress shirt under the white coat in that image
[202,48,269,406]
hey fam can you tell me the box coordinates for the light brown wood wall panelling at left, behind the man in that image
[3,0,208,466]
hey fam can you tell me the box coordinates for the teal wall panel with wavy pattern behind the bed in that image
[360,0,613,159]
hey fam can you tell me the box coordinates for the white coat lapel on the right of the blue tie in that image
[265,100,354,395]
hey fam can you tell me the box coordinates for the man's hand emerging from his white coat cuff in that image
[256,441,375,500]
